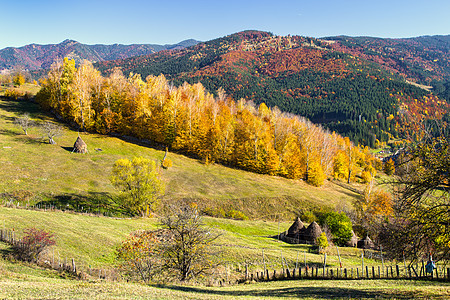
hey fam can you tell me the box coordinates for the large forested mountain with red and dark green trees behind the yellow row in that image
[95,31,450,146]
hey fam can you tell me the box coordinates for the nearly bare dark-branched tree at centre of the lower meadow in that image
[160,204,218,281]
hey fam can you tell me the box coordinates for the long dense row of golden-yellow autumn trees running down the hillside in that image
[37,58,375,186]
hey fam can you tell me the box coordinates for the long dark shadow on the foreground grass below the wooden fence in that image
[162,286,424,299]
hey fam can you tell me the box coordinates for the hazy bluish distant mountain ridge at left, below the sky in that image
[0,39,199,71]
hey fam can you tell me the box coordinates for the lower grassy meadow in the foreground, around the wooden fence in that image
[0,208,449,299]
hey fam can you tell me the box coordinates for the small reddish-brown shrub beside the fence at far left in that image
[13,228,56,262]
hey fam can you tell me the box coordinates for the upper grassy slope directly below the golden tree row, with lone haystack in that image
[0,98,357,219]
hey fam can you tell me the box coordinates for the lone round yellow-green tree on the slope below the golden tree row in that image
[111,157,165,216]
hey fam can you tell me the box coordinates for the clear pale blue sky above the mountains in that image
[0,0,450,49]
